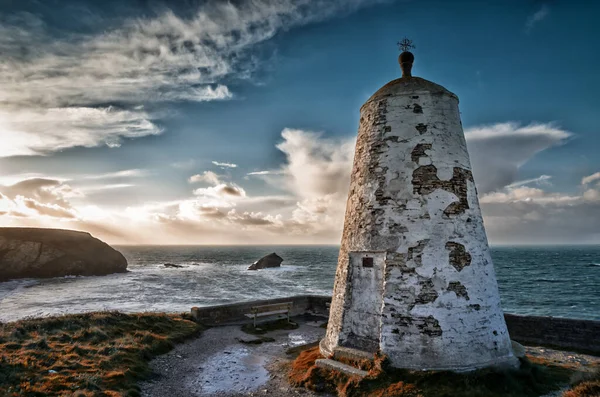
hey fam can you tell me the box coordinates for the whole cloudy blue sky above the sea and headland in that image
[0,0,600,245]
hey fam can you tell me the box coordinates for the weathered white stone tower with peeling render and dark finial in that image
[320,44,518,371]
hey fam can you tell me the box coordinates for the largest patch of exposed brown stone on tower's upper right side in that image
[412,164,473,216]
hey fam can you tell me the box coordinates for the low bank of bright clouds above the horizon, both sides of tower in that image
[0,123,600,244]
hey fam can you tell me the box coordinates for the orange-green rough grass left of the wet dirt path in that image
[0,312,201,397]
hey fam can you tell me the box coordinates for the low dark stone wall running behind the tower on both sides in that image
[192,295,600,355]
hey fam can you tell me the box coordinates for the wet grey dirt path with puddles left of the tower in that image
[140,319,325,397]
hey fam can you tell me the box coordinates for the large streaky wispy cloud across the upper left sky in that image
[0,0,377,157]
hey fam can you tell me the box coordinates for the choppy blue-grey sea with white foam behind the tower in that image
[0,245,600,322]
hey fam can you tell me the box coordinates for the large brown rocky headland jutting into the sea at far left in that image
[0,227,127,281]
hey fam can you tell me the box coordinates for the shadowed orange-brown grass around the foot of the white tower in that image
[289,347,588,397]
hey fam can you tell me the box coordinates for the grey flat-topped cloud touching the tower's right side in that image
[465,122,572,194]
